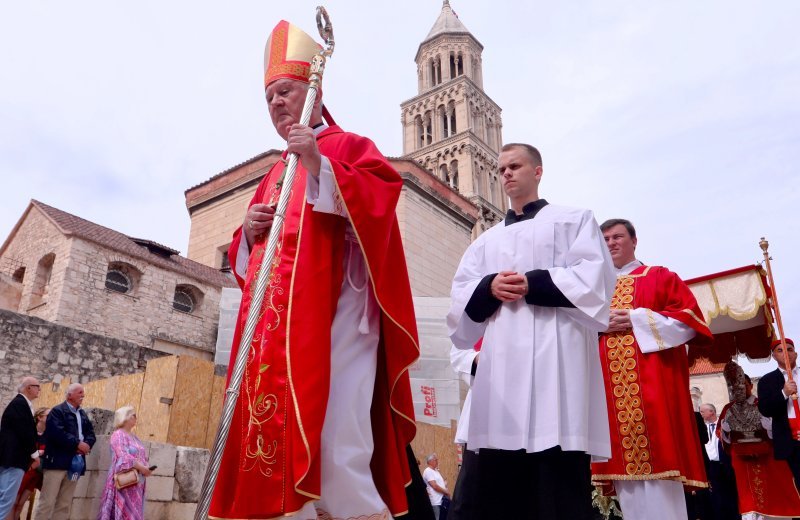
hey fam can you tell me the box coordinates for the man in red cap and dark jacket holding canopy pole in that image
[758,338,800,488]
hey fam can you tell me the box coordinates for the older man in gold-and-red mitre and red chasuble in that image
[210,21,419,520]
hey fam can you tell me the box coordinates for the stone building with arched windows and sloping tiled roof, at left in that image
[0,200,235,359]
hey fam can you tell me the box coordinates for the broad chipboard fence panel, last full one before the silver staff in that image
[167,356,214,448]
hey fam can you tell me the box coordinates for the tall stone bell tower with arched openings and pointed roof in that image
[400,0,508,238]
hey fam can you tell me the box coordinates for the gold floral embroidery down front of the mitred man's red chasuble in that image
[241,173,296,477]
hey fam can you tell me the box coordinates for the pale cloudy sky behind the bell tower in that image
[0,0,800,372]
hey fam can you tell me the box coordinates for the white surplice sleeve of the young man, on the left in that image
[447,238,492,350]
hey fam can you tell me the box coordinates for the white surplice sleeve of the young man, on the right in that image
[548,211,617,332]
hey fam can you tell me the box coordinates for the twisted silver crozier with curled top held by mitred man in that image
[194,7,334,520]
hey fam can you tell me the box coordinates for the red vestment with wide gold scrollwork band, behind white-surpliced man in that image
[592,266,712,494]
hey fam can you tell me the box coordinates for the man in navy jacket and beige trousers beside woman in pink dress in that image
[34,383,95,520]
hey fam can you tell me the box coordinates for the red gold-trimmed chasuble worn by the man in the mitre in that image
[210,126,419,519]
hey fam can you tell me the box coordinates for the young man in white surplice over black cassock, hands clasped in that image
[447,144,616,519]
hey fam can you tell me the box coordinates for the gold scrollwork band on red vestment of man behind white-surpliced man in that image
[606,276,652,475]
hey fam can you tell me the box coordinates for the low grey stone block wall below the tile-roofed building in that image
[0,310,164,409]
